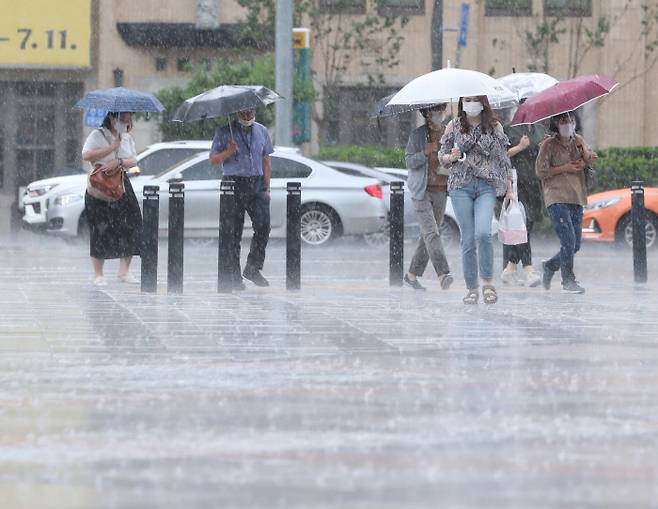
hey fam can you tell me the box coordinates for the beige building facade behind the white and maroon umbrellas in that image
[314,0,658,151]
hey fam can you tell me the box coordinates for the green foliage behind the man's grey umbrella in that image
[157,54,313,141]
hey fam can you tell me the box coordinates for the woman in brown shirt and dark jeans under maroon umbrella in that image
[535,112,596,293]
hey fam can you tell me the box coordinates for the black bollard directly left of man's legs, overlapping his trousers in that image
[217,177,234,293]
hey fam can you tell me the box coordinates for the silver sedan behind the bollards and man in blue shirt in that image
[48,148,386,245]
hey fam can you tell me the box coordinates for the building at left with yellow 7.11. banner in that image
[0,0,250,232]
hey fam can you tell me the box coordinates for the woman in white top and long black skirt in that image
[82,112,142,286]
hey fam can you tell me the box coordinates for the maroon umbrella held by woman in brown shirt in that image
[512,74,619,125]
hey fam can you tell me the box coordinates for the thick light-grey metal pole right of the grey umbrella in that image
[275,0,294,146]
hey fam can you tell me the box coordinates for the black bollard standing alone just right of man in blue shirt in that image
[286,182,302,290]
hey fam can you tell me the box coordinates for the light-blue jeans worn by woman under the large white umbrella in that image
[450,178,496,290]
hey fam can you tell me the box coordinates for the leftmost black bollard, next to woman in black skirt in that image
[141,186,160,293]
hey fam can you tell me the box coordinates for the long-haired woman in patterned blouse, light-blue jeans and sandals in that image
[439,96,512,304]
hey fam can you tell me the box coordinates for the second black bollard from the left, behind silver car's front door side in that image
[167,179,185,293]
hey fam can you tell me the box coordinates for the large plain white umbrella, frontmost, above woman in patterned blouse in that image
[387,68,516,108]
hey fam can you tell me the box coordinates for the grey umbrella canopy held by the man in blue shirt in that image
[172,85,282,122]
